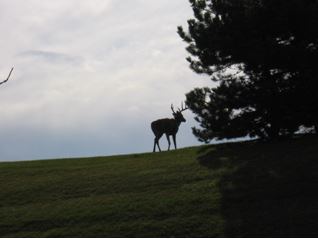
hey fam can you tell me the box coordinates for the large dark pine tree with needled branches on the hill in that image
[178,0,318,141]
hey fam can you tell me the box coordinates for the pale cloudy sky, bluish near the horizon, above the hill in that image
[0,0,212,161]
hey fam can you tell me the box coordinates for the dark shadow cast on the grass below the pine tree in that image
[198,137,318,237]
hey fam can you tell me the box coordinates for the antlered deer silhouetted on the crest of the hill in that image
[151,103,188,152]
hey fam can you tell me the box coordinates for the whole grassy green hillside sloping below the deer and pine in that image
[0,134,318,237]
